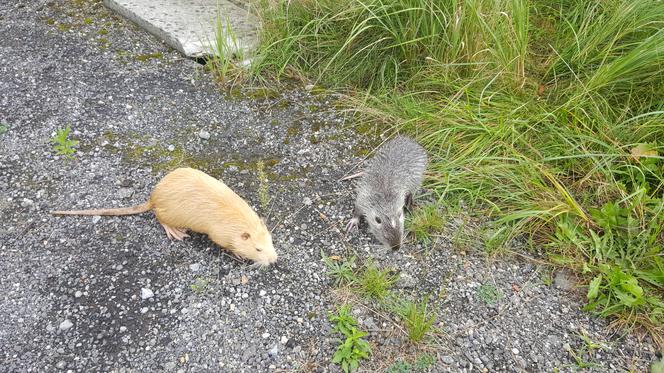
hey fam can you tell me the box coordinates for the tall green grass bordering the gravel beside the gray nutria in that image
[253,0,664,343]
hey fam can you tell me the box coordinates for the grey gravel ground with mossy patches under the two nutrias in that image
[0,0,657,372]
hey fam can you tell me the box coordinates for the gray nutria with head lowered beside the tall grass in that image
[346,136,427,249]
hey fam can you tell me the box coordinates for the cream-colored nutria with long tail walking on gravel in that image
[51,168,277,265]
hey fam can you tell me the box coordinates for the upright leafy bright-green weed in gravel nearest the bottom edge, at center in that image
[329,305,371,372]
